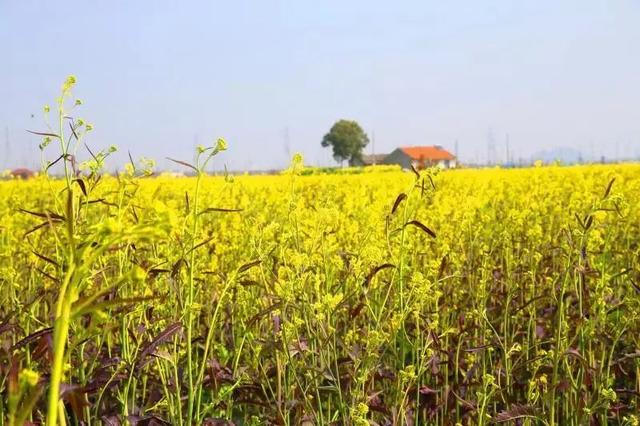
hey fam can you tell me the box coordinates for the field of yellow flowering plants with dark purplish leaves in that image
[0,161,640,426]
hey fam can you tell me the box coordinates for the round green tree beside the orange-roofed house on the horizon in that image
[322,120,369,165]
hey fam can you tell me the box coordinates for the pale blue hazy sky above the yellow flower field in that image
[0,0,640,170]
